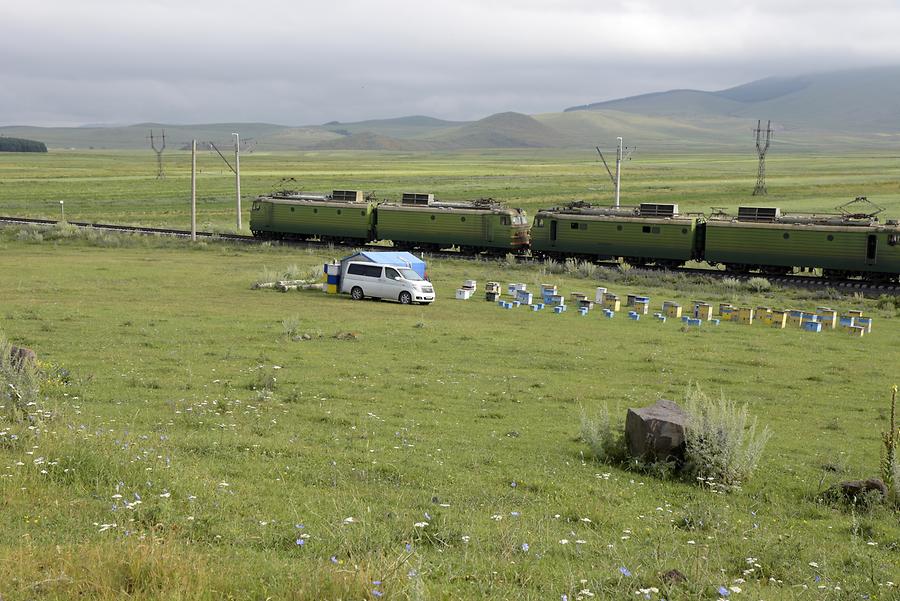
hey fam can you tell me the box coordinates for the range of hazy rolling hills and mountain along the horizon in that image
[0,66,900,152]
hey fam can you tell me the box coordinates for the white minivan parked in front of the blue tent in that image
[341,262,434,305]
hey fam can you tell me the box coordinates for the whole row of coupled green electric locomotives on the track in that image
[250,190,900,282]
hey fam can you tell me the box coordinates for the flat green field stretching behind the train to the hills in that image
[0,149,900,231]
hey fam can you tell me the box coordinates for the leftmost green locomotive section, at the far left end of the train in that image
[250,190,375,244]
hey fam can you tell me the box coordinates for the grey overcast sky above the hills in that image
[0,0,900,125]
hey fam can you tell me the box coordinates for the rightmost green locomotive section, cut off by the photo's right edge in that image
[704,207,900,279]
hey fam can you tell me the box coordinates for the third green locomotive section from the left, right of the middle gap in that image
[531,201,703,267]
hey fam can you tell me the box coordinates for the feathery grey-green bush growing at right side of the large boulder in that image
[684,386,771,487]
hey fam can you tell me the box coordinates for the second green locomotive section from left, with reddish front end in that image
[376,193,529,254]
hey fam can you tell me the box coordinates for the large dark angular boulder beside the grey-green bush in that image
[625,399,688,461]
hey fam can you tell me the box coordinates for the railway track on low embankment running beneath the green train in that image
[0,217,900,296]
